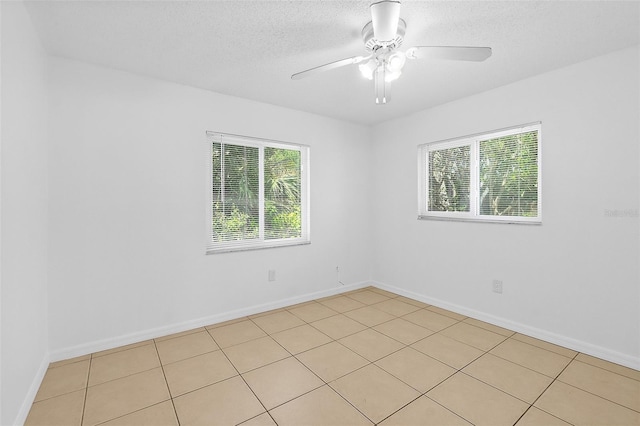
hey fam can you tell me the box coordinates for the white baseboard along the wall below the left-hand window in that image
[48,281,372,362]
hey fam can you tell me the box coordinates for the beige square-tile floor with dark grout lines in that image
[26,287,640,426]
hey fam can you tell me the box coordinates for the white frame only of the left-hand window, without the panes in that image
[206,131,311,254]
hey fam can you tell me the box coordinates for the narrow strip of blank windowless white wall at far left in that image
[0,2,48,425]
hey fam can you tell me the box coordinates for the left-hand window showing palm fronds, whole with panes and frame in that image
[207,132,310,253]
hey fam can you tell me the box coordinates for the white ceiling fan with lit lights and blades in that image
[291,0,491,104]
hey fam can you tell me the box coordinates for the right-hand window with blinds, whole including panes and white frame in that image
[418,123,542,223]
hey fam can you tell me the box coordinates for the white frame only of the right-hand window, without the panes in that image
[418,121,542,225]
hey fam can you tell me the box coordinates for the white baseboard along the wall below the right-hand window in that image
[371,281,640,370]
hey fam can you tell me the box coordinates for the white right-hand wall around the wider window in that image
[372,48,640,368]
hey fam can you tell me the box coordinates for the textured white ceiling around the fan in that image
[22,0,640,124]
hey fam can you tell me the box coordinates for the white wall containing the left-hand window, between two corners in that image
[49,59,371,358]
